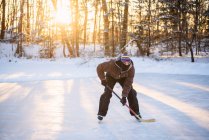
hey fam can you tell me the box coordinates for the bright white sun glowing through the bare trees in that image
[54,0,71,24]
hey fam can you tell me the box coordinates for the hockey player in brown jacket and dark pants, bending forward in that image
[97,55,141,120]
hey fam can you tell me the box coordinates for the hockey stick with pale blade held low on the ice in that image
[106,86,155,122]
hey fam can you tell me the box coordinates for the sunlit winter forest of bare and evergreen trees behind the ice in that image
[0,0,209,62]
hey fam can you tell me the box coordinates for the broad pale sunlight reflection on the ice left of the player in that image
[31,80,65,140]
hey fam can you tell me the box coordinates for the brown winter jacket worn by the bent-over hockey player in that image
[97,60,135,97]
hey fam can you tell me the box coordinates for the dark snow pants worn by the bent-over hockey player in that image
[98,76,139,116]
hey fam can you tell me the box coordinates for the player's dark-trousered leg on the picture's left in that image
[97,76,116,116]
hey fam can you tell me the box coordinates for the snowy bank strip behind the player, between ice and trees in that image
[0,57,209,82]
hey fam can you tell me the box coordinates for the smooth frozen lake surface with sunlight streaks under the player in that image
[0,73,209,140]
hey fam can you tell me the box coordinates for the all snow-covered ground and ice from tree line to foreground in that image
[0,42,209,140]
